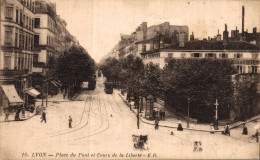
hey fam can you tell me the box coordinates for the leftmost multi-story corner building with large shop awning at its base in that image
[0,0,35,114]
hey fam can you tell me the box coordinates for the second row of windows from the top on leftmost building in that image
[5,27,34,50]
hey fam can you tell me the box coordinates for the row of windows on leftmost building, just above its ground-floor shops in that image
[4,53,33,70]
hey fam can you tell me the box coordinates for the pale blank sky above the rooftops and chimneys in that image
[51,0,260,63]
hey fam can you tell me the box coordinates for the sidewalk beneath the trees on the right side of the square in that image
[115,90,260,132]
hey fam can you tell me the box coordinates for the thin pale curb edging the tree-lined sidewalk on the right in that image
[118,93,260,133]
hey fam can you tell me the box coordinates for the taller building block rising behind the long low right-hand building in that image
[112,22,189,58]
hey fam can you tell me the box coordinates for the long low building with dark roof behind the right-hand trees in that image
[141,41,260,73]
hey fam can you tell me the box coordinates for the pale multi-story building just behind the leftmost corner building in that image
[34,0,56,72]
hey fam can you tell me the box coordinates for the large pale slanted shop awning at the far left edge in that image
[1,85,23,106]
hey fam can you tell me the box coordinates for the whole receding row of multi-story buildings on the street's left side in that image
[0,0,79,114]
